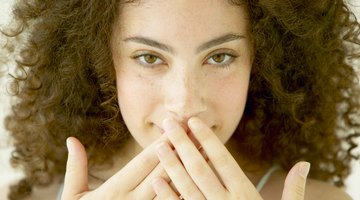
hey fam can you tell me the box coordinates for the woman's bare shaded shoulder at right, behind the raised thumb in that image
[261,171,352,200]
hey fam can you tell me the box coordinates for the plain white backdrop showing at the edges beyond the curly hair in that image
[0,0,360,200]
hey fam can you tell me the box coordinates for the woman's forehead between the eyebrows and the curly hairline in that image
[117,0,248,39]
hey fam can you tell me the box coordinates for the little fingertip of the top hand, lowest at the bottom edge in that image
[152,177,179,200]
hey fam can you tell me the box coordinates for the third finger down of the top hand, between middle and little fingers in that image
[157,143,205,199]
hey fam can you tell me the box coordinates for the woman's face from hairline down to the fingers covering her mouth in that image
[111,0,251,147]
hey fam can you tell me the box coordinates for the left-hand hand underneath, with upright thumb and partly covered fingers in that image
[61,136,169,200]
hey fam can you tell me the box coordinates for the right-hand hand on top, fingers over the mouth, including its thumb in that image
[153,118,309,200]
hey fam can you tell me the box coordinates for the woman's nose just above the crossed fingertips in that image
[165,67,207,123]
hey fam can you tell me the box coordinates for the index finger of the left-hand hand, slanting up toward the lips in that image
[99,135,168,195]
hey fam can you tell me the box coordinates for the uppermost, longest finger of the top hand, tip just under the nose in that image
[188,118,256,192]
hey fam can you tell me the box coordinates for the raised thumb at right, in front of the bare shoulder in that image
[281,162,310,200]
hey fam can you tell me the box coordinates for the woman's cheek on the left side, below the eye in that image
[116,69,163,148]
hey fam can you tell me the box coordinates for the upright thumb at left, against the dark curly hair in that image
[61,137,88,200]
